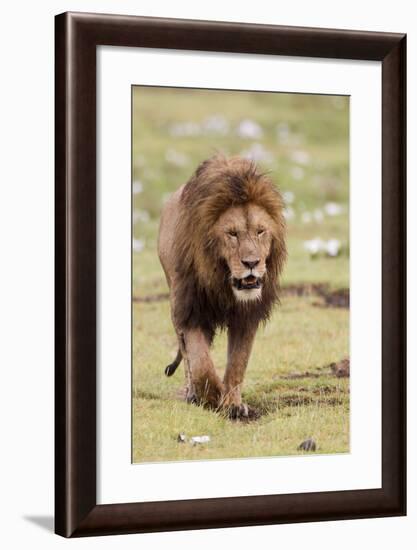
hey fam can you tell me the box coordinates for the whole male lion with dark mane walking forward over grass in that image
[158,156,286,418]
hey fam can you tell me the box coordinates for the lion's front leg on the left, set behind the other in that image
[182,329,223,408]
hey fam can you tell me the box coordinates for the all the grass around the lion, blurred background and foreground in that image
[132,88,349,462]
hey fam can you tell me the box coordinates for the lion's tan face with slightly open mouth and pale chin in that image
[213,204,273,301]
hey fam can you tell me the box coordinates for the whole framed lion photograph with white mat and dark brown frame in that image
[55,13,406,537]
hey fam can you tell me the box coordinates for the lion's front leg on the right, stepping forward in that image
[222,327,256,418]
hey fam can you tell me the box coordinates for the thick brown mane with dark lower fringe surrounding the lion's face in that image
[174,156,286,339]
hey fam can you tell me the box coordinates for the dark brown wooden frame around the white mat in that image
[55,13,406,537]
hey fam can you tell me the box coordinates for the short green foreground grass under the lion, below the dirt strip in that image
[133,297,349,462]
